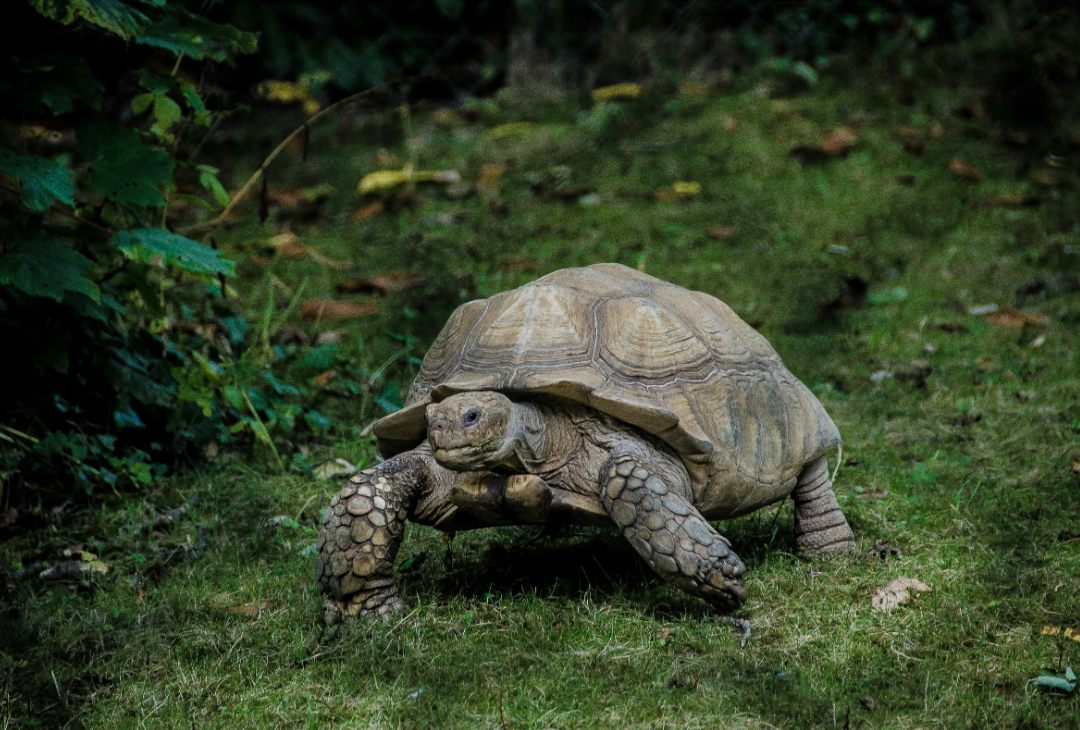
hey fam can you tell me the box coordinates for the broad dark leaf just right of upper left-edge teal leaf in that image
[77,124,175,207]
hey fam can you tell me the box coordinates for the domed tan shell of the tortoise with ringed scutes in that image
[375,263,839,486]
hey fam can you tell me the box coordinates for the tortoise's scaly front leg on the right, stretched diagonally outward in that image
[600,454,746,610]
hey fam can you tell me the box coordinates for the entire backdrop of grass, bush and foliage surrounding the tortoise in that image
[0,0,1080,728]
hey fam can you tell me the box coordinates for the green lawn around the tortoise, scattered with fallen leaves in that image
[0,48,1080,728]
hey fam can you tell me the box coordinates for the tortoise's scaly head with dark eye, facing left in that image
[427,391,519,471]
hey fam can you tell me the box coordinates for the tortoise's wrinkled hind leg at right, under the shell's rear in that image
[792,457,858,557]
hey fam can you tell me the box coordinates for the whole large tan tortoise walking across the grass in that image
[316,263,854,622]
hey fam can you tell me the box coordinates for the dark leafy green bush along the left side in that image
[0,0,336,502]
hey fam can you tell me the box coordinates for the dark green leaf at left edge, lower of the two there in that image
[0,238,102,301]
